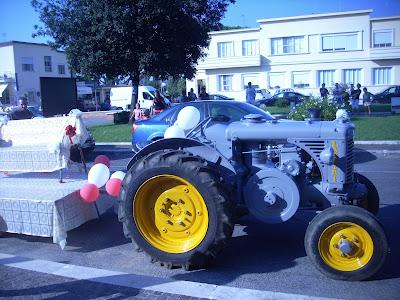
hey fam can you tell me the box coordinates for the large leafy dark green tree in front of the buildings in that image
[31,0,235,108]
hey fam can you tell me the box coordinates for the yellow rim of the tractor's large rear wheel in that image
[133,175,208,253]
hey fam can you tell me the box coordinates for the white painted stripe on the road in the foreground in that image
[0,253,338,300]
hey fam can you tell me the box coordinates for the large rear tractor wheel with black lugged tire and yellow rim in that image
[119,150,234,269]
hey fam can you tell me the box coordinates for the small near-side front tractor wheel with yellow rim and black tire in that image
[304,206,388,281]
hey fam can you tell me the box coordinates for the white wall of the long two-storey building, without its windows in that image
[188,10,400,98]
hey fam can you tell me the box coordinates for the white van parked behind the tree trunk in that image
[110,85,169,110]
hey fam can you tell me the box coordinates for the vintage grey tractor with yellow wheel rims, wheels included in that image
[118,115,388,280]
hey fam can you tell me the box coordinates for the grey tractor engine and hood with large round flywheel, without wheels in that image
[225,115,358,223]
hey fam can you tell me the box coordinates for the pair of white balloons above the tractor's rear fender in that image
[164,106,200,139]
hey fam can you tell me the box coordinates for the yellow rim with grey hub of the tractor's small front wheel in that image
[318,222,374,272]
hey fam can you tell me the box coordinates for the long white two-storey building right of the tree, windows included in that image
[187,10,400,99]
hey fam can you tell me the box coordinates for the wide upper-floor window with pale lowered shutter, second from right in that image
[322,32,361,52]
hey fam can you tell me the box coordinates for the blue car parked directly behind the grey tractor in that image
[132,100,273,152]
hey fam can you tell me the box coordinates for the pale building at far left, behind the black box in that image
[0,41,71,105]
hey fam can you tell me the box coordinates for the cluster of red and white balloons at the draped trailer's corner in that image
[79,155,125,203]
